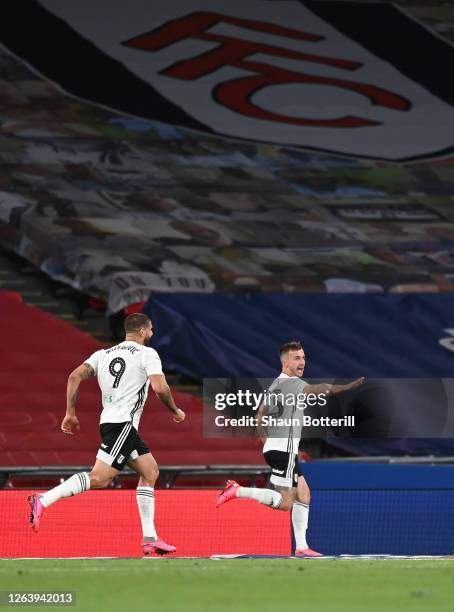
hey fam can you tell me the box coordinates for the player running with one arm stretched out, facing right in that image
[216,342,364,557]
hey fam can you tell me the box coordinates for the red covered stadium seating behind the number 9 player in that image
[0,292,263,467]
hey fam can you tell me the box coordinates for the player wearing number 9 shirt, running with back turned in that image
[28,313,185,554]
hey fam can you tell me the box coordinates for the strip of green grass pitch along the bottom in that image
[0,558,454,612]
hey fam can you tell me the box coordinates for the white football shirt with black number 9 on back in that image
[85,340,162,429]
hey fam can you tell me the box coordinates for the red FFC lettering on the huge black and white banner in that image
[124,12,411,128]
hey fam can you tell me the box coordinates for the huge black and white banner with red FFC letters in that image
[0,0,454,161]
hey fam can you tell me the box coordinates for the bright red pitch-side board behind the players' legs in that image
[0,490,291,558]
